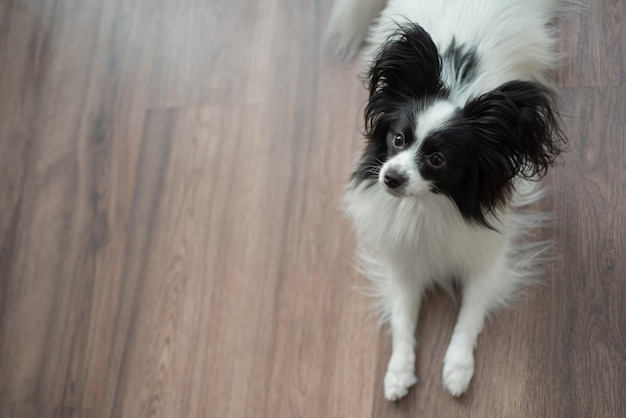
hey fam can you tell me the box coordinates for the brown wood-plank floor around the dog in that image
[0,0,626,418]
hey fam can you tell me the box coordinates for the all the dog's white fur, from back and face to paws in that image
[328,0,557,400]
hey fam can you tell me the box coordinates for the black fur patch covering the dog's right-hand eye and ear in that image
[418,81,566,227]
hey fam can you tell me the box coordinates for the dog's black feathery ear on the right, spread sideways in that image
[462,81,567,224]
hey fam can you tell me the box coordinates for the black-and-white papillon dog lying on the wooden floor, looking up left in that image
[326,0,567,401]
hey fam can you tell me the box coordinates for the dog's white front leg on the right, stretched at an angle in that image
[443,255,510,396]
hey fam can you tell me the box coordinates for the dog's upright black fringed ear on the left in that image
[365,23,443,140]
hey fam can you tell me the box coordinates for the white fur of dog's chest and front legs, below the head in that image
[346,178,546,400]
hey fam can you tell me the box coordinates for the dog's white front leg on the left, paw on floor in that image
[385,277,422,401]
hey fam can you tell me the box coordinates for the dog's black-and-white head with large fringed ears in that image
[354,25,565,225]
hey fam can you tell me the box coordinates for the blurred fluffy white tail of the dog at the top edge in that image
[324,0,387,61]
